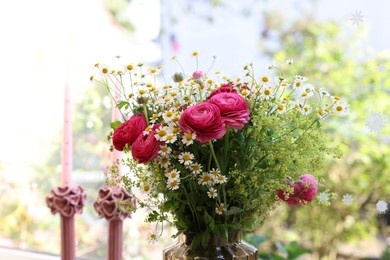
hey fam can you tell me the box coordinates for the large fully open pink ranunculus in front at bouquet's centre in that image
[179,102,226,143]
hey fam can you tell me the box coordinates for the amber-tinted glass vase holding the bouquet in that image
[163,231,258,260]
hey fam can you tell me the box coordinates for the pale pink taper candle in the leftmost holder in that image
[61,85,73,187]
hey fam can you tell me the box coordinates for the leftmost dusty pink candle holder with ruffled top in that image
[46,186,87,260]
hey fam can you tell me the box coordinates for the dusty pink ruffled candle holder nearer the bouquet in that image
[93,187,136,260]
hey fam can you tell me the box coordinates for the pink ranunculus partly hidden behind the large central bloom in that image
[208,92,250,130]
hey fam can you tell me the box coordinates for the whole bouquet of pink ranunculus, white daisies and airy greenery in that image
[93,52,349,247]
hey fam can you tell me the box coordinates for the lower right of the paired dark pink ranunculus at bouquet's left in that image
[131,124,164,163]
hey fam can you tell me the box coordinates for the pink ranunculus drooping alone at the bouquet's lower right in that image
[277,174,318,206]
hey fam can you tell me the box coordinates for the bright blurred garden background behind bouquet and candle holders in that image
[0,0,390,259]
